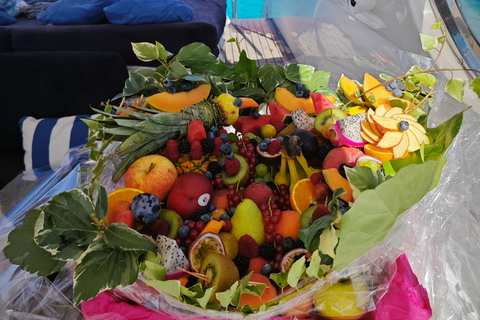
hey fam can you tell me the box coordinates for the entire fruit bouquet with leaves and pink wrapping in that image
[3,23,480,319]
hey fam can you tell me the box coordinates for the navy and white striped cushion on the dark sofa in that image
[20,115,88,177]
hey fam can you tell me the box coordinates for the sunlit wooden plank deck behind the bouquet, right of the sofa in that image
[223,19,295,67]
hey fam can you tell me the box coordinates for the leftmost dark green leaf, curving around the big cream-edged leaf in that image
[3,209,65,276]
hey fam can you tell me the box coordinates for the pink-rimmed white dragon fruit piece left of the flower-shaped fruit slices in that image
[330,113,367,147]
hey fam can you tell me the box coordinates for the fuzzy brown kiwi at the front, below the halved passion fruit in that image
[198,252,240,301]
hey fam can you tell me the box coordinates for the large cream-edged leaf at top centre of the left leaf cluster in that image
[34,189,98,261]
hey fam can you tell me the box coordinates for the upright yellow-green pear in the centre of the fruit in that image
[230,199,265,245]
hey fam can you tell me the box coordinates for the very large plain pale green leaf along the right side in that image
[333,156,447,271]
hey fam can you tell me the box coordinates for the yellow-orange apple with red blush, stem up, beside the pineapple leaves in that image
[125,155,178,201]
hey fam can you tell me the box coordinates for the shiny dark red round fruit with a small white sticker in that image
[167,172,213,220]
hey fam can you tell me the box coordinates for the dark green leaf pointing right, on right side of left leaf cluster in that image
[103,222,157,252]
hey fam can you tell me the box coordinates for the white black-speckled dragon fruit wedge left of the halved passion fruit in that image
[156,235,190,280]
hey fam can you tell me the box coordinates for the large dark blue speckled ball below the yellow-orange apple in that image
[130,193,162,226]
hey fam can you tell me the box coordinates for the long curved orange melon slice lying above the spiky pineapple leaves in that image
[145,83,211,112]
